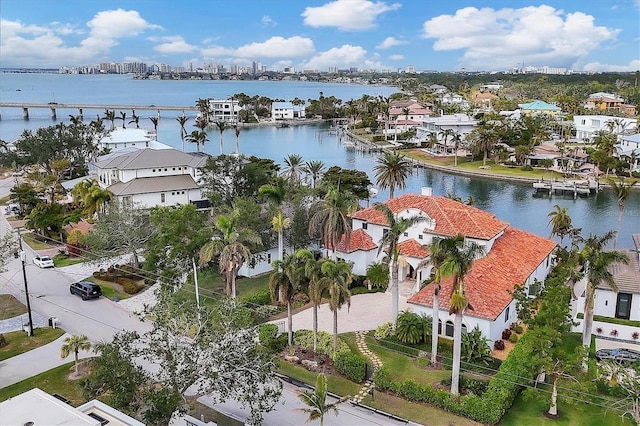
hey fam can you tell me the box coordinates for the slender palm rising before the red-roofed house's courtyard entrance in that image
[374,204,427,323]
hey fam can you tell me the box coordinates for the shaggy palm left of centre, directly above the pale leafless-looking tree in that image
[199,209,262,298]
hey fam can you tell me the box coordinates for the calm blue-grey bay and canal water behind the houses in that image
[0,74,640,247]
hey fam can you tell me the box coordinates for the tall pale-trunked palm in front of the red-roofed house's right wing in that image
[440,236,484,395]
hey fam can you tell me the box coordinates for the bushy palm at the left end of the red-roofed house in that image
[309,187,358,260]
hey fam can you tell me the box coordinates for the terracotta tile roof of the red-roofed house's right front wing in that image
[408,227,556,320]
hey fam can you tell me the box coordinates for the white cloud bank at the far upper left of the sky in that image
[0,9,162,67]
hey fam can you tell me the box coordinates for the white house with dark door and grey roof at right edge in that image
[571,234,640,349]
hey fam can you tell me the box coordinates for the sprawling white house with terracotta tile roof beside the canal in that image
[336,188,556,341]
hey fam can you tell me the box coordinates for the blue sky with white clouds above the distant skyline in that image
[0,0,640,71]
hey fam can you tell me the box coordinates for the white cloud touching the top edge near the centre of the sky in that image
[302,0,402,31]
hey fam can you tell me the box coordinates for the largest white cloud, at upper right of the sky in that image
[423,5,619,69]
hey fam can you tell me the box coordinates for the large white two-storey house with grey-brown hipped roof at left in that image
[94,148,208,208]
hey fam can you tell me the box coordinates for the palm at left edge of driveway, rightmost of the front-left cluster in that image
[320,260,353,352]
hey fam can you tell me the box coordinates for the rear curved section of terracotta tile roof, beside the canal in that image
[352,194,508,240]
